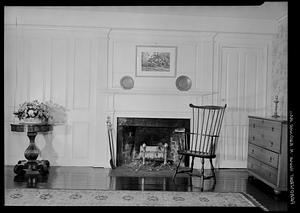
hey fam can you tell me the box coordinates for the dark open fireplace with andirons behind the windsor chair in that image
[116,117,190,166]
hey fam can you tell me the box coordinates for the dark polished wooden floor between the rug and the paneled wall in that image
[5,166,288,211]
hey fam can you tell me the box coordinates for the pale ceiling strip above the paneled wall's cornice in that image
[35,2,288,20]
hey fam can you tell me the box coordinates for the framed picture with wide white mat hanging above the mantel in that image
[136,46,177,77]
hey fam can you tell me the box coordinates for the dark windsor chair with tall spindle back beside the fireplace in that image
[173,104,227,190]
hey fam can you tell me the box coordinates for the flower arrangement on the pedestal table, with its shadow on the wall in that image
[13,100,66,123]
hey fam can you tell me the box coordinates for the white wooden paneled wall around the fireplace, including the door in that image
[4,14,272,168]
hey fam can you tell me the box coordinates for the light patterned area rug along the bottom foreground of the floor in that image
[5,188,267,210]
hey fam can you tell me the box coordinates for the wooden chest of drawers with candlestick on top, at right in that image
[247,116,288,194]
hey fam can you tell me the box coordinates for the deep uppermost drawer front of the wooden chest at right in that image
[248,119,281,153]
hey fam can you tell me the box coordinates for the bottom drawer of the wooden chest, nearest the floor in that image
[247,156,278,185]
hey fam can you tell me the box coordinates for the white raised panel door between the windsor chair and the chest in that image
[218,47,266,168]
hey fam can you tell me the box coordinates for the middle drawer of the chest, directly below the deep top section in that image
[248,143,279,168]
